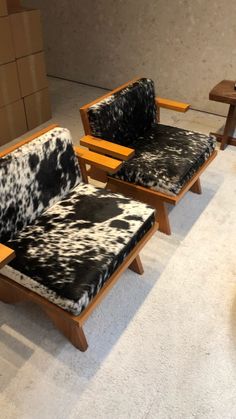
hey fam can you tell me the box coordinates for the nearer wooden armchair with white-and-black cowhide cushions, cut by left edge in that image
[0,125,157,351]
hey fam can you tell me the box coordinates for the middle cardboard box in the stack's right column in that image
[16,52,48,97]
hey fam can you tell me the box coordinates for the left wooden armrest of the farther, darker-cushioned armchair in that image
[80,135,135,160]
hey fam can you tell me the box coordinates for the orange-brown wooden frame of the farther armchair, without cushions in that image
[80,78,217,235]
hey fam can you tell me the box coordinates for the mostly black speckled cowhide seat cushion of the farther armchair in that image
[110,124,216,196]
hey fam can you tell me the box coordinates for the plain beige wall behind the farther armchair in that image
[23,0,236,113]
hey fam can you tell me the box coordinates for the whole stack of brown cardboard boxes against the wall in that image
[0,0,51,146]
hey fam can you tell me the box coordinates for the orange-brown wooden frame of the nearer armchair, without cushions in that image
[0,125,158,352]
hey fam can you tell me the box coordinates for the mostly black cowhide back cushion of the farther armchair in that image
[88,78,157,145]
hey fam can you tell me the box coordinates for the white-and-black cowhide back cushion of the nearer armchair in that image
[0,127,81,243]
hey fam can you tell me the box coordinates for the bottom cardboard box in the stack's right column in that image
[24,89,52,130]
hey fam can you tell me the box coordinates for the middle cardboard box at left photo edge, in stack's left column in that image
[0,62,21,107]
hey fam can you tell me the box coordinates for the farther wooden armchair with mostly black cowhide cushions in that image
[80,78,216,234]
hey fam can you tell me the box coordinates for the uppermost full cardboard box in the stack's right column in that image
[10,10,43,58]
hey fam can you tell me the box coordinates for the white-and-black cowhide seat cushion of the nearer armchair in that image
[0,184,154,315]
